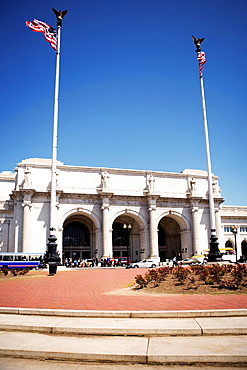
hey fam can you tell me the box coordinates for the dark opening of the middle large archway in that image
[112,215,142,262]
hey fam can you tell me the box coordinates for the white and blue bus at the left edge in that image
[0,252,44,270]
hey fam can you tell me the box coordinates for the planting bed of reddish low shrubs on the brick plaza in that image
[135,264,247,294]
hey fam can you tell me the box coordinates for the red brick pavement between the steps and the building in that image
[0,268,247,311]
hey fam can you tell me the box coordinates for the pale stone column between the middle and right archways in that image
[148,199,159,258]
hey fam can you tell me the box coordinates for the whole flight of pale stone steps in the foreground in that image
[0,309,247,366]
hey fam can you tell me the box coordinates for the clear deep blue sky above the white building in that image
[0,0,247,206]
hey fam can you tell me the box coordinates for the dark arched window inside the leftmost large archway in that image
[63,222,90,247]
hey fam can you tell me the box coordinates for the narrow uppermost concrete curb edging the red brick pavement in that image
[0,307,247,318]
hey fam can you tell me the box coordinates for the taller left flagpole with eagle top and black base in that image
[45,8,67,275]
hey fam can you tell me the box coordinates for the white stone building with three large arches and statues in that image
[0,158,247,261]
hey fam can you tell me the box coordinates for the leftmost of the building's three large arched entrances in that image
[62,214,95,261]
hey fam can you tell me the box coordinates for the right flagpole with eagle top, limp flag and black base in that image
[192,36,221,262]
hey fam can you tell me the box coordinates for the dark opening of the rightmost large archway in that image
[158,216,182,262]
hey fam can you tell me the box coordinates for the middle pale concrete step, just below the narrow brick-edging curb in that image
[0,314,247,338]
